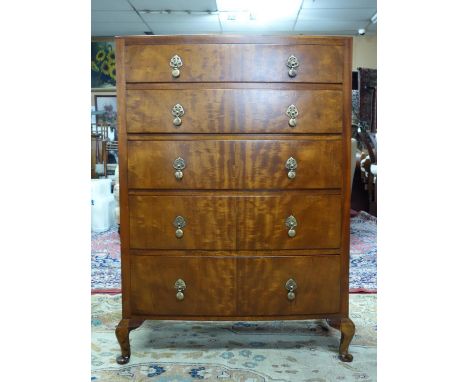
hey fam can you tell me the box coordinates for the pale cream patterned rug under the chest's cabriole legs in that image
[91,294,377,382]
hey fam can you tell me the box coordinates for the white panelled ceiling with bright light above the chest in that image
[91,0,377,37]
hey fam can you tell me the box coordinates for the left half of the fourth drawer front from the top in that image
[128,195,236,250]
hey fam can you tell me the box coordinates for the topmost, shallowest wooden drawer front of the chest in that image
[125,44,344,83]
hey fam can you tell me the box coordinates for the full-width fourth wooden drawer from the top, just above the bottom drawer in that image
[128,192,341,250]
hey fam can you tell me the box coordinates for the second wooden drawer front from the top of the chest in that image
[127,89,343,134]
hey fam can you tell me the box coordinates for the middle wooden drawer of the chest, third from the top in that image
[128,137,342,189]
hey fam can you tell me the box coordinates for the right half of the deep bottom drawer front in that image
[237,255,340,316]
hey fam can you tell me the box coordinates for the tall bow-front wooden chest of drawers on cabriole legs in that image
[116,36,354,363]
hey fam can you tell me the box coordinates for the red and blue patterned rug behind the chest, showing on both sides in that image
[91,211,377,293]
